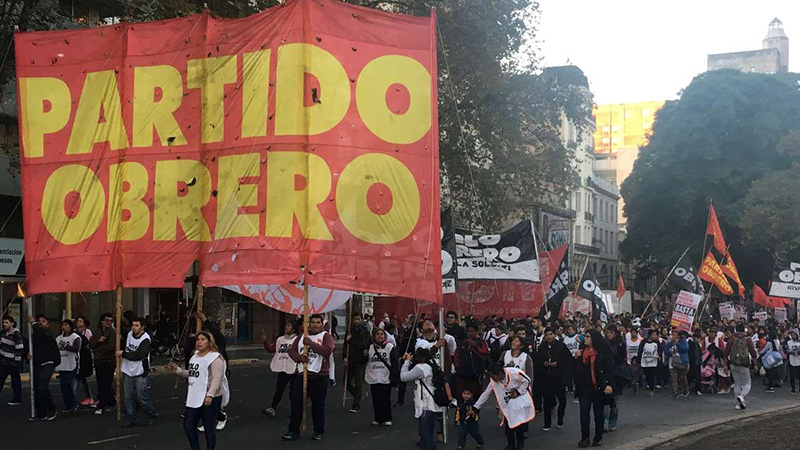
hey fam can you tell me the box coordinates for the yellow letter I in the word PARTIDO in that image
[242,50,271,137]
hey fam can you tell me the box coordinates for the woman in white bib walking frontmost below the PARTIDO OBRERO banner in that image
[170,330,230,450]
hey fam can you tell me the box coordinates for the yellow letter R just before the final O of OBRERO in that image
[266,152,333,241]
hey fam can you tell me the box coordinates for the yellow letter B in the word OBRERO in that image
[106,162,150,242]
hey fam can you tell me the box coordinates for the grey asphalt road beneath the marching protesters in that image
[0,350,800,450]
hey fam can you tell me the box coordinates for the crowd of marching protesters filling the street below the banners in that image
[0,311,800,450]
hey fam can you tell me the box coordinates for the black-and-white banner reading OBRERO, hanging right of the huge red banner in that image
[455,220,540,283]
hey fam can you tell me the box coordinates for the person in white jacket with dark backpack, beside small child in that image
[400,347,443,450]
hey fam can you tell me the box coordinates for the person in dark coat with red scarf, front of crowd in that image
[575,329,614,448]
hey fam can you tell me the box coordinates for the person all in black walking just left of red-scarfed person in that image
[535,328,572,431]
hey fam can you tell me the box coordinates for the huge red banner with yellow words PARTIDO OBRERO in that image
[15,0,441,301]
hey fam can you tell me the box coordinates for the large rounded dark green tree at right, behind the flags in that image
[622,71,800,282]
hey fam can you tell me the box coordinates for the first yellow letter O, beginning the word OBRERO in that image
[42,164,106,245]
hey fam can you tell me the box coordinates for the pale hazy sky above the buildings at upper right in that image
[537,0,800,104]
